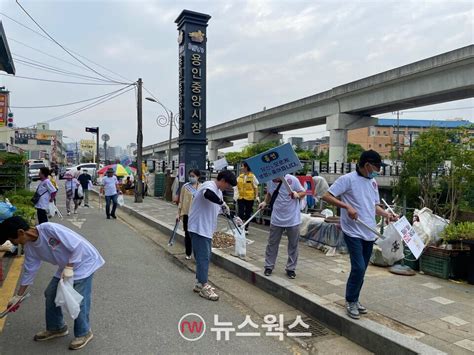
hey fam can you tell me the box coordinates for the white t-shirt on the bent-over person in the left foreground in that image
[21,222,105,285]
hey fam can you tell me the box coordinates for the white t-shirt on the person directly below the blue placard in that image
[267,174,305,227]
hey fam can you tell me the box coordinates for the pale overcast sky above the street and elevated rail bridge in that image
[0,0,474,152]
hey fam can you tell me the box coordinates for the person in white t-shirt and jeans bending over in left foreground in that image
[0,216,105,350]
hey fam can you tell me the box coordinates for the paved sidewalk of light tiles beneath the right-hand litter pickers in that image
[113,196,474,354]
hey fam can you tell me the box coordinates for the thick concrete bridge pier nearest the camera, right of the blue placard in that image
[326,113,378,164]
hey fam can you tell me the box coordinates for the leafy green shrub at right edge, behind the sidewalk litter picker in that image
[396,128,474,220]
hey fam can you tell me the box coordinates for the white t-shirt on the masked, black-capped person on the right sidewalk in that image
[329,171,380,241]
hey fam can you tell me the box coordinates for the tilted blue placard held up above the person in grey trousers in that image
[245,143,303,183]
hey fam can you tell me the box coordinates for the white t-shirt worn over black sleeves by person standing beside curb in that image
[188,181,222,238]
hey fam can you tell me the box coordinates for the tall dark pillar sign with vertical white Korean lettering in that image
[175,10,211,171]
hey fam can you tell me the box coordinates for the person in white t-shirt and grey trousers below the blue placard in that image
[258,174,306,279]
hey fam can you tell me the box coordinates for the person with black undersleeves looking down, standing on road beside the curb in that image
[188,170,237,301]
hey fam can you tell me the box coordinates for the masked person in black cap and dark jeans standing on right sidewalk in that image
[323,150,398,319]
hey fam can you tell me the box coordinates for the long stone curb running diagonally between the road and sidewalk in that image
[100,195,445,355]
